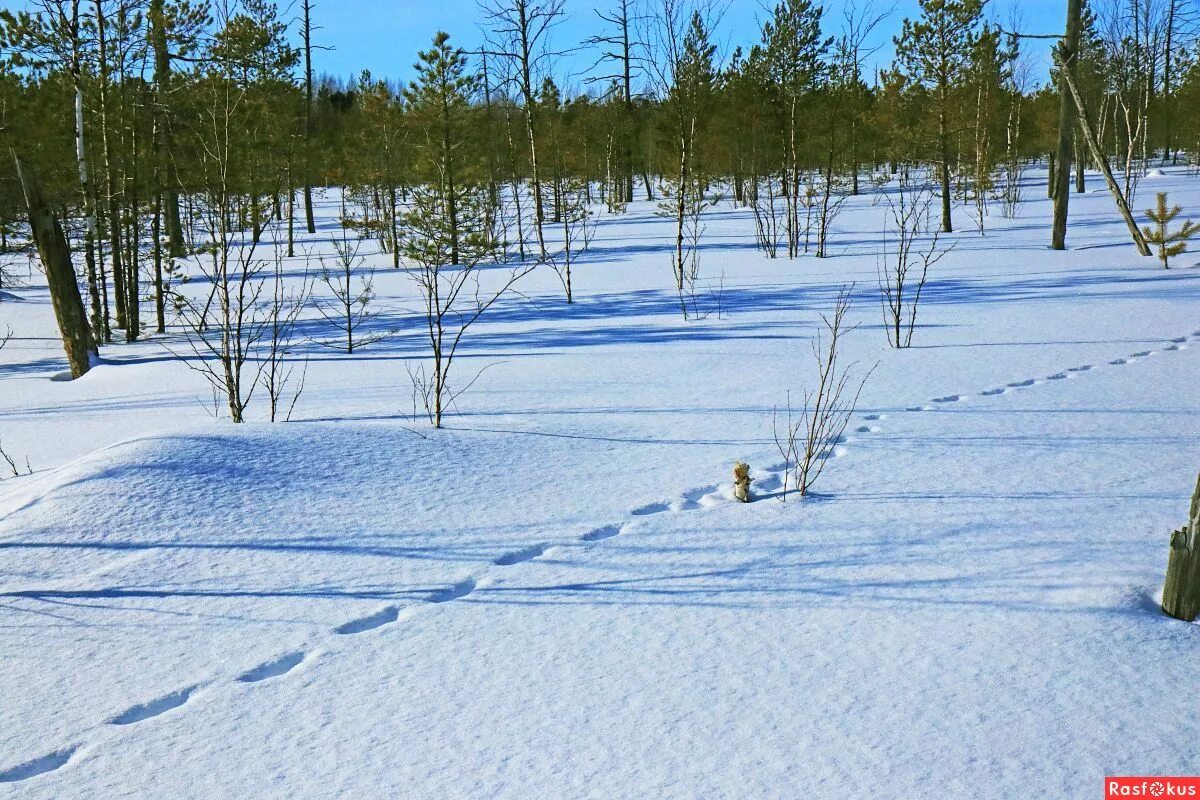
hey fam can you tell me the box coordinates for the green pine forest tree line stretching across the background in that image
[0,0,1200,352]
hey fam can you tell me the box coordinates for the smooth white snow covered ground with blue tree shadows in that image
[0,169,1200,799]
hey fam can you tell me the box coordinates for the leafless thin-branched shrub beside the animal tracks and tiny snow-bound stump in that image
[772,285,874,500]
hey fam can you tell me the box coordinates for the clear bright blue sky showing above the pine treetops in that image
[313,0,1067,89]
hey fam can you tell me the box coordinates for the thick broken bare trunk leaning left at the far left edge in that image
[10,150,96,378]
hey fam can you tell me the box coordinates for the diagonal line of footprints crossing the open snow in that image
[0,331,1200,783]
